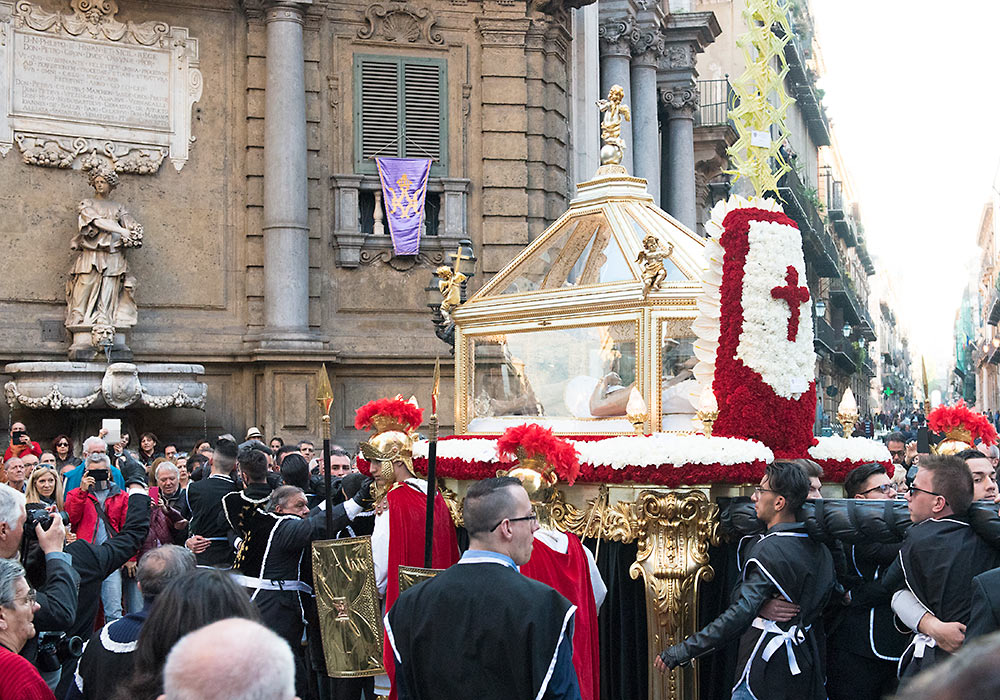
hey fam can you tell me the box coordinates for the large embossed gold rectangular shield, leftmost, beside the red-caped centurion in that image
[312,537,385,678]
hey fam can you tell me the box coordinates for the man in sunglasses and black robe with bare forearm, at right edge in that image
[892,456,1000,679]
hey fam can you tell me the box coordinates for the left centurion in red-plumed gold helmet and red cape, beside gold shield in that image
[354,396,458,697]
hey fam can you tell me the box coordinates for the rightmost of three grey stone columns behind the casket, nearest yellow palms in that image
[662,82,700,231]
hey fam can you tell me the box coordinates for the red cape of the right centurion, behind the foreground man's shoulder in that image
[521,533,601,700]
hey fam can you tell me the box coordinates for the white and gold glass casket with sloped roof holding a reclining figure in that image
[454,175,704,435]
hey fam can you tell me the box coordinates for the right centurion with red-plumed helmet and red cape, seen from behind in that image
[497,423,608,700]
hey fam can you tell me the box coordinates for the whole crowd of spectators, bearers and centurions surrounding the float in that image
[0,412,1000,700]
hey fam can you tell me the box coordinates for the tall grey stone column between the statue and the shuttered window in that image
[263,2,309,344]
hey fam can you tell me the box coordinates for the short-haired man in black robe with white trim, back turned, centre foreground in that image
[385,477,580,700]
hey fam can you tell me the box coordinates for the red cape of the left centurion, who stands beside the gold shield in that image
[382,483,459,698]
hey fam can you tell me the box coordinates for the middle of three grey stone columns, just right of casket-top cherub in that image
[631,29,664,206]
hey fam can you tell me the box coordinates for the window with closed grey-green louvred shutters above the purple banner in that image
[354,56,448,177]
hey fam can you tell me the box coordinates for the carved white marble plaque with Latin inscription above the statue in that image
[0,0,202,175]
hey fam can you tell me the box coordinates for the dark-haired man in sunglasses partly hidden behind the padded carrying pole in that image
[826,463,909,700]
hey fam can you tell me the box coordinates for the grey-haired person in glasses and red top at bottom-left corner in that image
[0,559,54,700]
